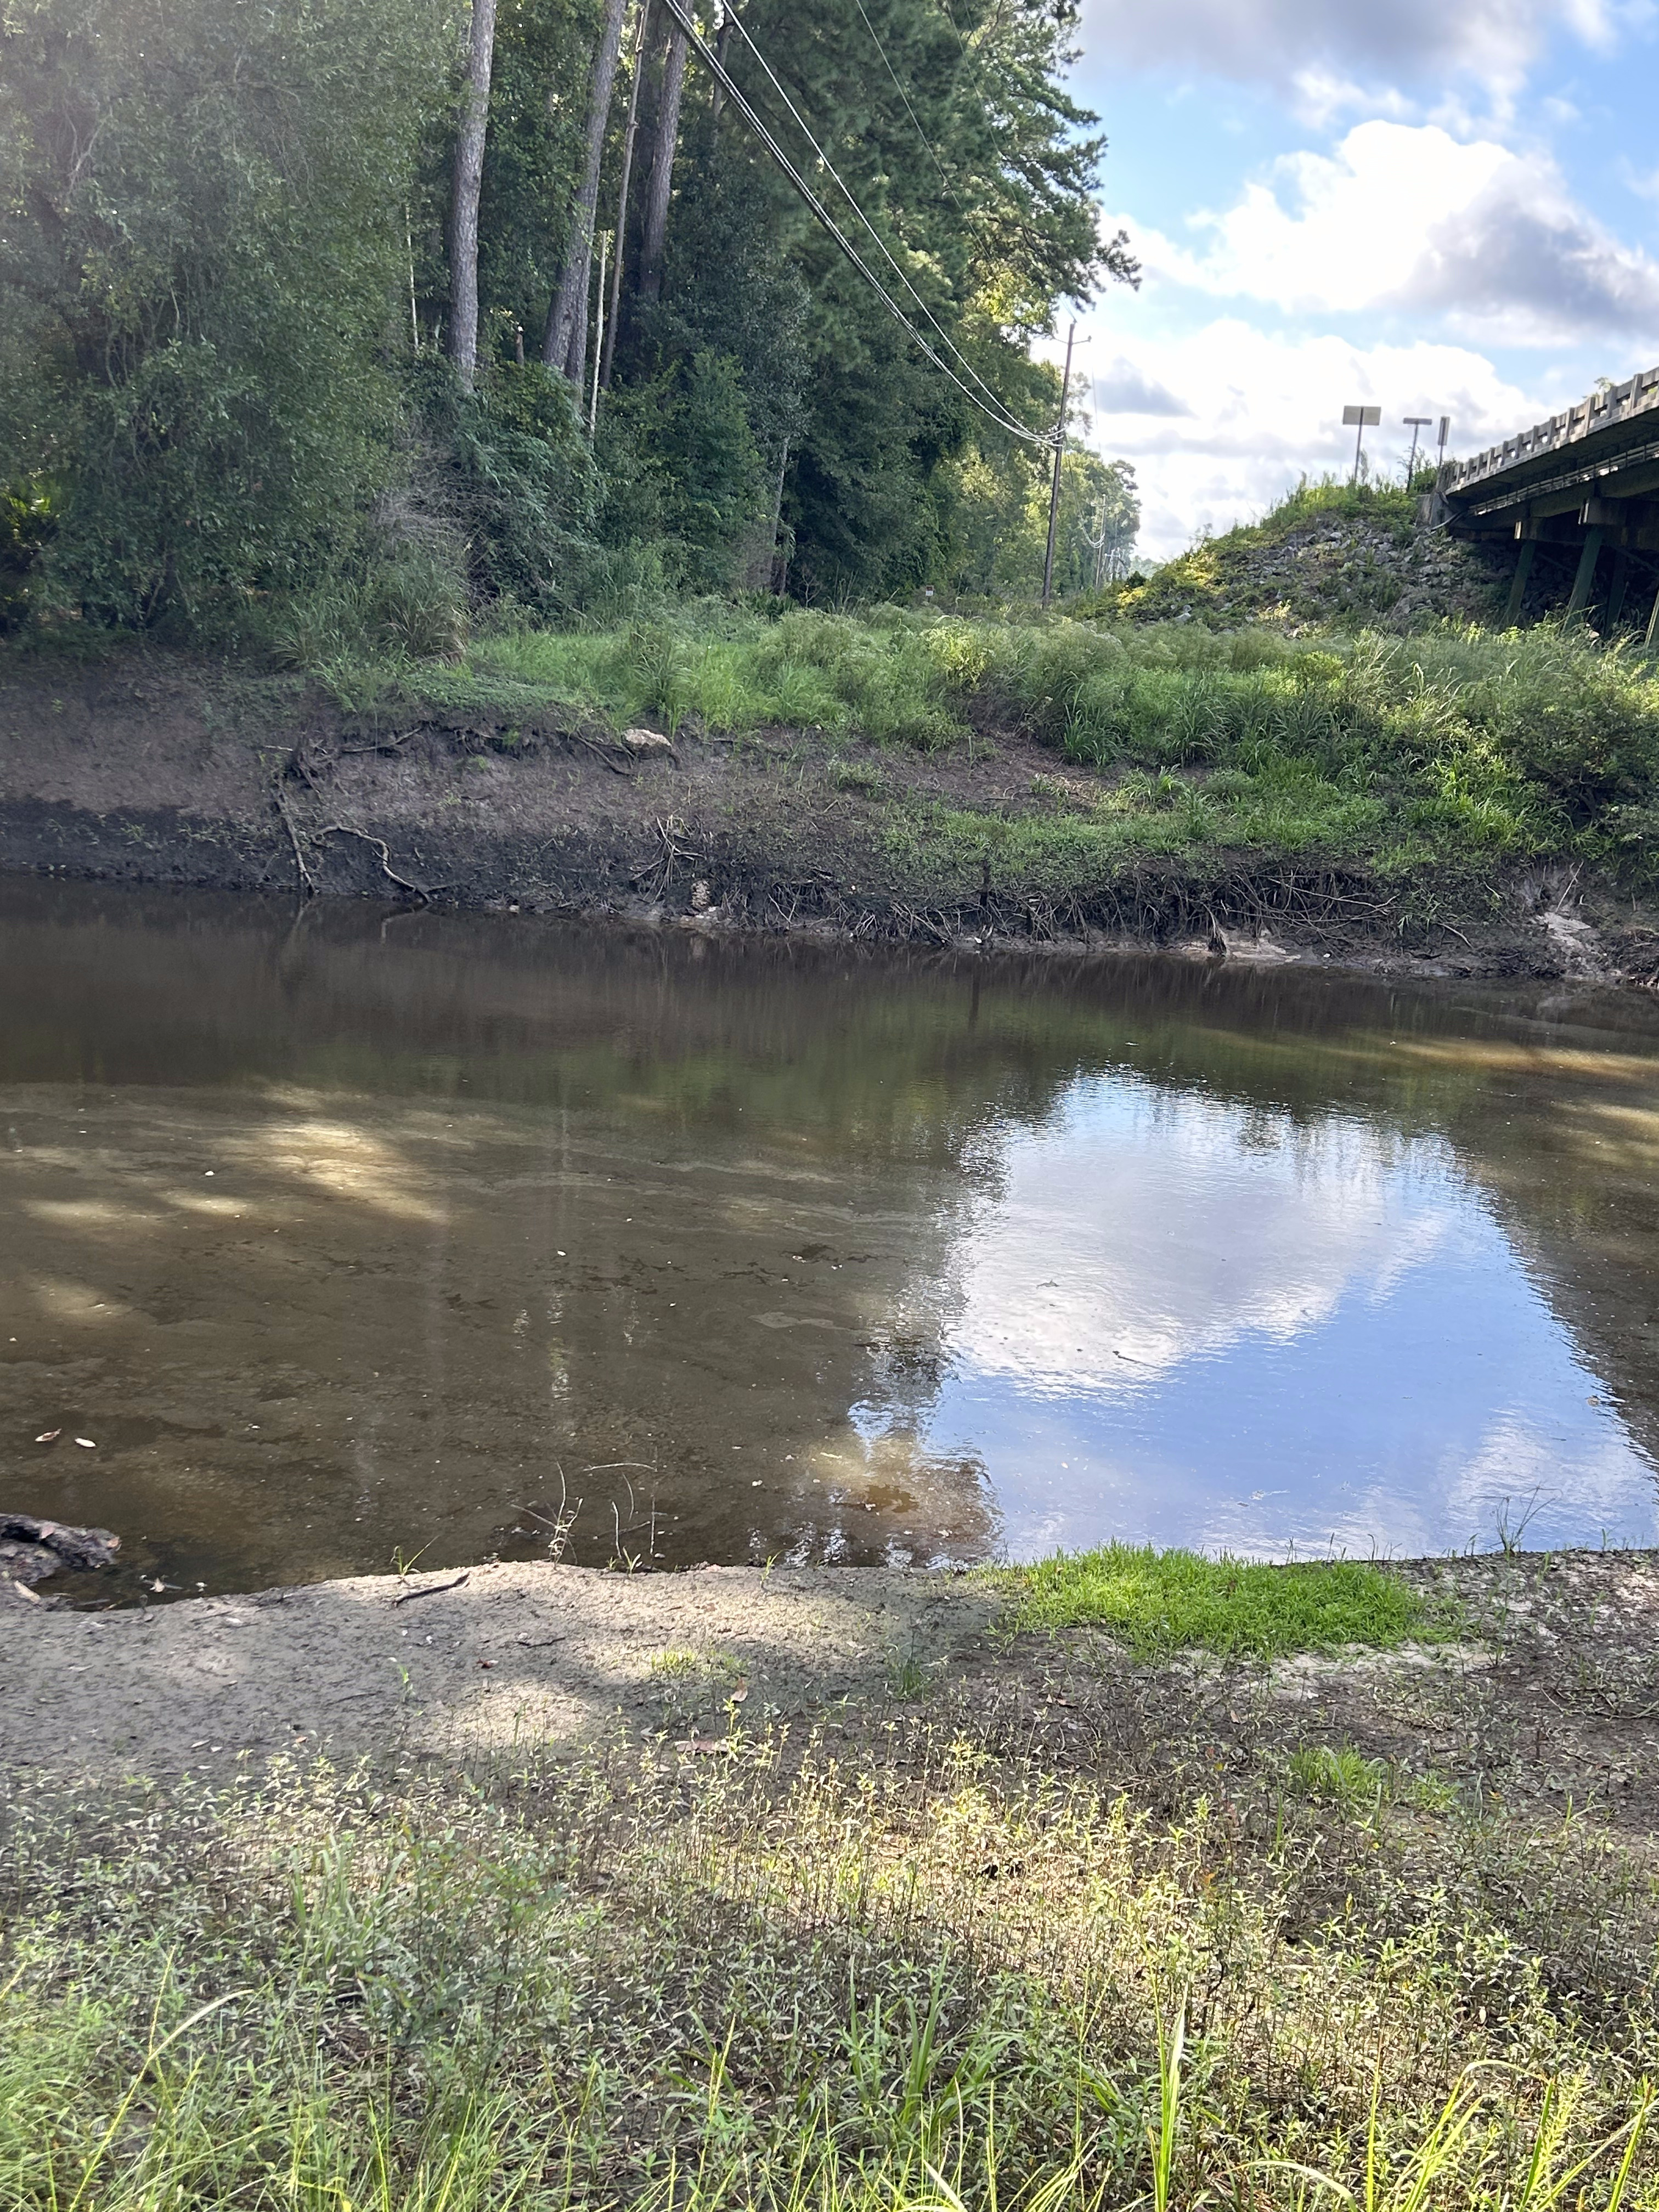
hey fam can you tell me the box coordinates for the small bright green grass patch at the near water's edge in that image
[997,1544,1451,1661]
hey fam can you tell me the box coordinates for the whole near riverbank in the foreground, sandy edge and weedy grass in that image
[0,1553,1659,2208]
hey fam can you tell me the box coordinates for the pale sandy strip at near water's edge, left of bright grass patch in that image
[0,1562,1000,1776]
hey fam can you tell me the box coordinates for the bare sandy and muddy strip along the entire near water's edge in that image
[0,1553,1659,1849]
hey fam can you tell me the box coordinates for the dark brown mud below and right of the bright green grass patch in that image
[953,1550,1659,1865]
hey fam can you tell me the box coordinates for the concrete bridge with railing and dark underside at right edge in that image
[1434,367,1659,644]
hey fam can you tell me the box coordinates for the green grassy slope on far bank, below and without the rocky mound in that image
[338,588,1659,916]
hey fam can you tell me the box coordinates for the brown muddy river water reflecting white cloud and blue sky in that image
[0,878,1659,1595]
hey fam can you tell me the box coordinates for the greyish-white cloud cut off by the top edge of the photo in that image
[1082,0,1650,104]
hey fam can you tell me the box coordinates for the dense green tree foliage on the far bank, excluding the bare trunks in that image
[0,0,1130,637]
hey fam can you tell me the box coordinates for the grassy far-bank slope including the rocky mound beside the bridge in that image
[9,487,1659,934]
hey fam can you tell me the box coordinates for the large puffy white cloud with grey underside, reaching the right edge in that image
[1135,120,1659,345]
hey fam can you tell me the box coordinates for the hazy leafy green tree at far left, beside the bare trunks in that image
[0,0,447,622]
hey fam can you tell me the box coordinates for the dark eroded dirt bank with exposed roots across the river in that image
[0,652,1659,984]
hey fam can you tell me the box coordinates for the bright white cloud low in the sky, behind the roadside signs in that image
[1084,320,1575,560]
